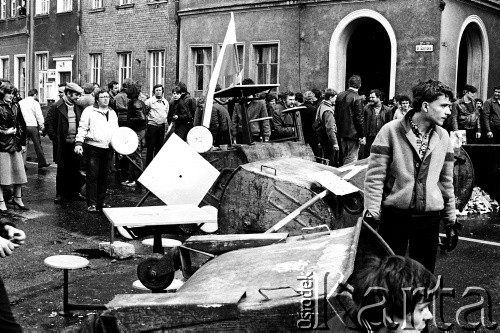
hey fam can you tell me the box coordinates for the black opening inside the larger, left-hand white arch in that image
[346,18,392,100]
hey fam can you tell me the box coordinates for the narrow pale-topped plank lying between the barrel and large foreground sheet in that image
[184,233,288,254]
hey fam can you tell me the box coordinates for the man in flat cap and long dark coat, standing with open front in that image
[45,82,83,204]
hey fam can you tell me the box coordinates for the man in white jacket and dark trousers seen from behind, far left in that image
[19,89,50,169]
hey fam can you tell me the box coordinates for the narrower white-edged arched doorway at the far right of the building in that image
[455,15,489,99]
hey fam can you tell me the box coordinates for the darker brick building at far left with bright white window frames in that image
[0,0,80,104]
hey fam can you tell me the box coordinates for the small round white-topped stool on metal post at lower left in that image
[44,255,106,317]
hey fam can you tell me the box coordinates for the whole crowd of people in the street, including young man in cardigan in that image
[0,75,500,331]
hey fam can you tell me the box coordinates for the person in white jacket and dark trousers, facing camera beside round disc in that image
[75,88,118,213]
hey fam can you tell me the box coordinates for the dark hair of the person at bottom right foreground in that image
[353,255,437,323]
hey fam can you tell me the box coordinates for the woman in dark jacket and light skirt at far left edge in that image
[0,82,28,215]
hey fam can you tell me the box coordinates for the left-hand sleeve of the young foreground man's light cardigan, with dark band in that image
[364,126,392,219]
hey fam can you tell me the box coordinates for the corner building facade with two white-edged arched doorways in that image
[179,0,500,98]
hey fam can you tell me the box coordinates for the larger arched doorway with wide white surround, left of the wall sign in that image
[328,9,397,98]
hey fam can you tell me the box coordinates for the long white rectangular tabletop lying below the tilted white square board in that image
[103,204,217,227]
